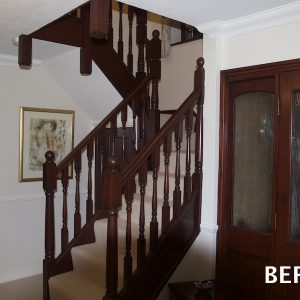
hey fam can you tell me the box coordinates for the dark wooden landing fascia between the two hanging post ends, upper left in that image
[30,16,83,47]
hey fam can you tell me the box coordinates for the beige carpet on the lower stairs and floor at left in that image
[0,149,194,300]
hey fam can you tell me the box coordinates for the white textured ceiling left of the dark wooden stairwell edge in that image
[0,0,86,59]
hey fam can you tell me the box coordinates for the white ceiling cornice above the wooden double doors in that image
[196,2,300,39]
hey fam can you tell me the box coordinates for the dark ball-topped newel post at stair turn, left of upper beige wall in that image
[148,30,161,138]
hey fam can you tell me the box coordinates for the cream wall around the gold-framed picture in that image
[0,65,90,283]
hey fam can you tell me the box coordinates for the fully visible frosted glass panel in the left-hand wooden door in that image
[232,92,274,232]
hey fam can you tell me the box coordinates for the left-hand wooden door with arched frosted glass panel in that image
[228,77,276,300]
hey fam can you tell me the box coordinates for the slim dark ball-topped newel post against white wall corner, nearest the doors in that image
[192,57,205,228]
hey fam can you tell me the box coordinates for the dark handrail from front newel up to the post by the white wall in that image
[121,90,202,185]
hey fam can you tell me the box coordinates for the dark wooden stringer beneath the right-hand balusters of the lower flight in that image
[119,197,200,300]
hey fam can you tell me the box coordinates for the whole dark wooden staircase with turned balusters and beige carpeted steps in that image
[19,0,204,300]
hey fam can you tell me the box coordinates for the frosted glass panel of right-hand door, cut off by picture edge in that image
[291,91,300,240]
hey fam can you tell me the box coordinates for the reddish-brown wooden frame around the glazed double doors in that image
[216,59,300,289]
